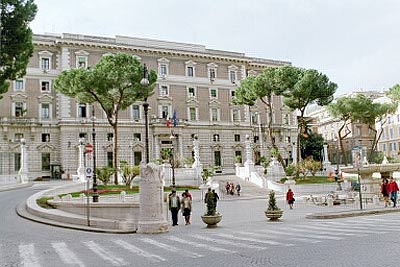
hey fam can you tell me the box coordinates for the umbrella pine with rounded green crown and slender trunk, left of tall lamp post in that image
[54,53,157,183]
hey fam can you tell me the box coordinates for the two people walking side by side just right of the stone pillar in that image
[168,189,193,226]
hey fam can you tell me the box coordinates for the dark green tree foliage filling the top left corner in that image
[0,0,37,99]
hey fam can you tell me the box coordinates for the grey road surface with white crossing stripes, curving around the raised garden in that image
[0,186,400,267]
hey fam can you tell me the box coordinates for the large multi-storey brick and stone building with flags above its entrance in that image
[0,34,296,179]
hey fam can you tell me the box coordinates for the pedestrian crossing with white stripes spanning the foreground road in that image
[0,216,400,267]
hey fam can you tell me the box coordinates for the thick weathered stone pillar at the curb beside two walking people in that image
[137,162,169,234]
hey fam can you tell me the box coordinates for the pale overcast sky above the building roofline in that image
[31,0,400,95]
